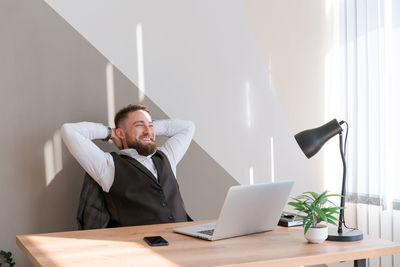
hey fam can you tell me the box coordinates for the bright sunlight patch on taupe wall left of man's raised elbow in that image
[43,130,63,186]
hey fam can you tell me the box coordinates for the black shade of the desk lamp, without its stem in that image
[294,119,342,158]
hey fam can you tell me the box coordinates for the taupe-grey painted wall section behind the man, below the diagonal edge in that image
[0,0,237,266]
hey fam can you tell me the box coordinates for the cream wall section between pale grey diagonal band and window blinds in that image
[243,0,330,190]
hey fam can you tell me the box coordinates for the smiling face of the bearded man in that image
[122,110,156,156]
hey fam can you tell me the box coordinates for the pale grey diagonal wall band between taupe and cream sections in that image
[46,0,313,195]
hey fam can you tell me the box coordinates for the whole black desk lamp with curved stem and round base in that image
[294,119,363,241]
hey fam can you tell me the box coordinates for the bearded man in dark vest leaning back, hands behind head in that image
[61,105,195,226]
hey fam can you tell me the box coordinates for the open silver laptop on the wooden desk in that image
[174,181,294,240]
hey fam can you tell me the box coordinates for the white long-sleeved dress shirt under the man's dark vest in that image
[61,120,195,192]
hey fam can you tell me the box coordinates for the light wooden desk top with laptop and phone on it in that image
[17,221,400,267]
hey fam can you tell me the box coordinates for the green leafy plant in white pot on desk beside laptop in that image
[288,191,341,243]
